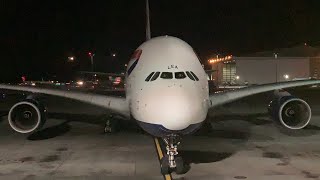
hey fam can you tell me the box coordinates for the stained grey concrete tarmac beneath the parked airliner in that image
[0,89,320,180]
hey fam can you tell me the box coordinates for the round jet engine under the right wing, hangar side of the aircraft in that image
[268,96,311,130]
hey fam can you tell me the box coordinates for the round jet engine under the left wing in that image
[8,99,46,134]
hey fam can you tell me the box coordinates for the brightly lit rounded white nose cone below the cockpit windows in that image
[132,88,207,130]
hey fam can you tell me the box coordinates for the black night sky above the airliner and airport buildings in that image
[0,0,320,81]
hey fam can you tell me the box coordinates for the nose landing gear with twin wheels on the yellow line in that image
[161,134,186,174]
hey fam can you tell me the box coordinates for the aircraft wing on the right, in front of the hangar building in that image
[209,80,320,108]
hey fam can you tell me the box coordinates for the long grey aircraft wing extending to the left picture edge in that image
[0,84,130,117]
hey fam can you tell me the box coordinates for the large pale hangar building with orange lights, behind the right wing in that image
[209,45,320,86]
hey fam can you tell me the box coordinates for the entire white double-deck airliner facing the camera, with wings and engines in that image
[0,0,320,174]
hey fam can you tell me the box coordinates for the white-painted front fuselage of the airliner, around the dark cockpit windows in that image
[126,36,209,130]
